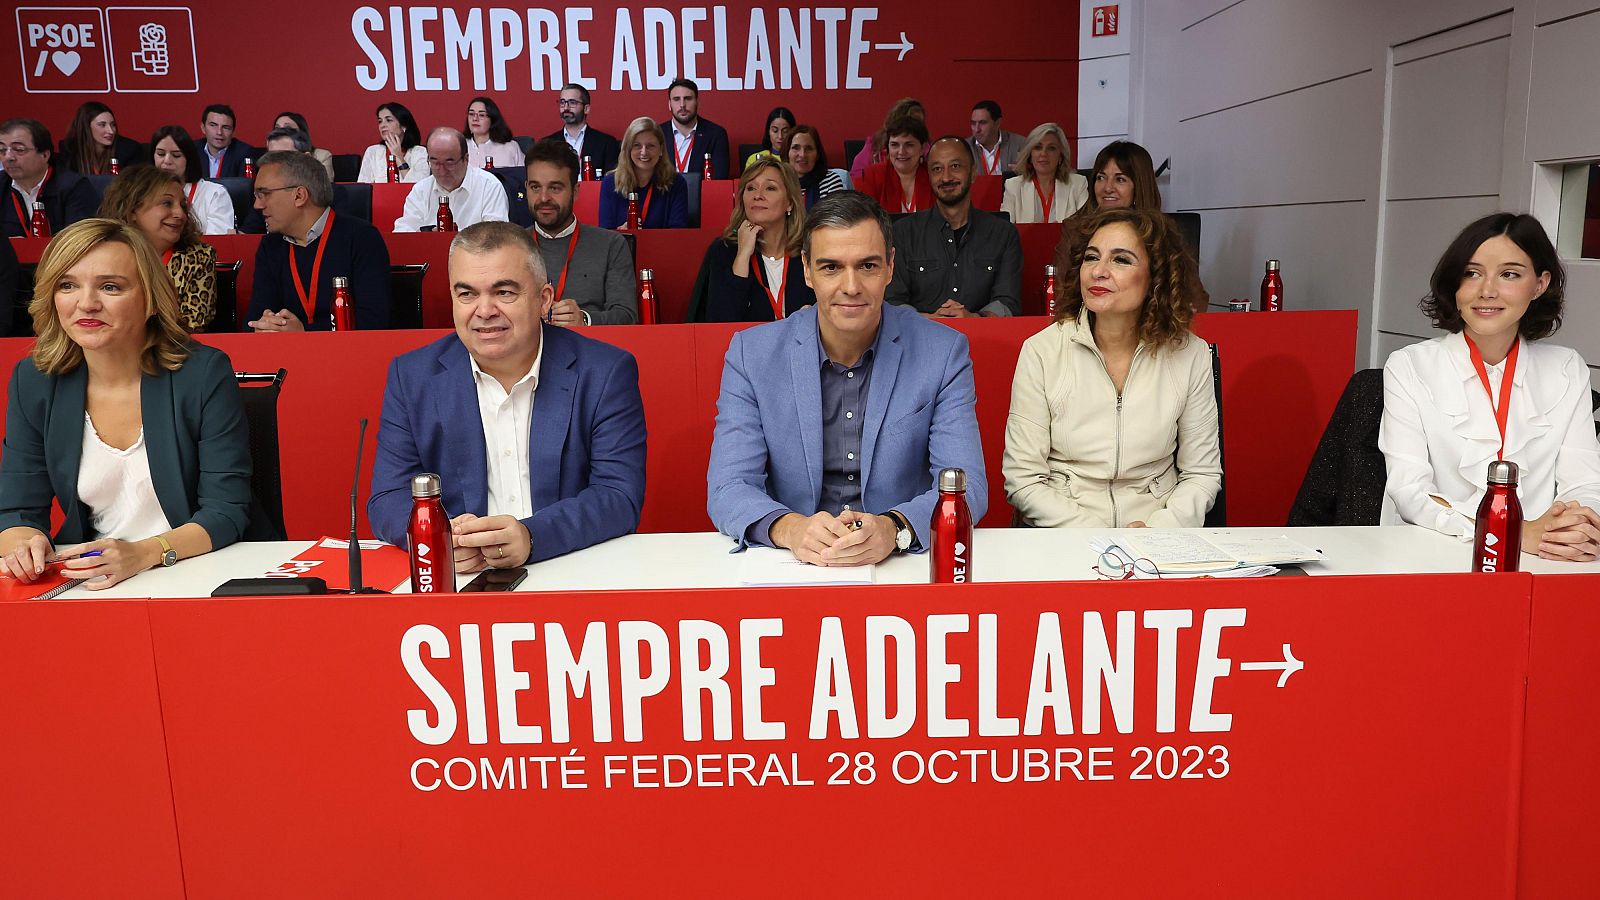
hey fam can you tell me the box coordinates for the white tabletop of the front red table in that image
[53,525,1600,599]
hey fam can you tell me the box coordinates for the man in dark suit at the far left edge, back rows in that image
[0,119,99,238]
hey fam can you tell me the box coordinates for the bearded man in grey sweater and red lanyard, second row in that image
[526,138,638,327]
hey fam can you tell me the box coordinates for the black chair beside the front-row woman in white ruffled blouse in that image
[1290,368,1389,527]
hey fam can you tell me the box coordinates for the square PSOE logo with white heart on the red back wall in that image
[16,6,110,94]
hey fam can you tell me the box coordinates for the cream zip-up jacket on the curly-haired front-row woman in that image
[1003,315,1222,528]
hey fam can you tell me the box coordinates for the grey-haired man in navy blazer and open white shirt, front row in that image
[366,223,645,573]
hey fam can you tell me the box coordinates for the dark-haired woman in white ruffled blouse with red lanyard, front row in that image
[1378,213,1600,560]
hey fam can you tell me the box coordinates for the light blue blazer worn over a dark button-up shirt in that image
[706,303,989,549]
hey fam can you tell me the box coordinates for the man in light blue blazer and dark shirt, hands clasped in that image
[706,191,989,565]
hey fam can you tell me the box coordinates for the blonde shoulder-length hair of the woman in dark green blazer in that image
[27,219,189,375]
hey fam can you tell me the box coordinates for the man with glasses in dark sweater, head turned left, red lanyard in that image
[248,151,390,331]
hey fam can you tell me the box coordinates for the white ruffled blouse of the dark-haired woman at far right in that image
[1378,335,1600,534]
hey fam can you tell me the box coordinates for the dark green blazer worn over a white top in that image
[0,341,251,549]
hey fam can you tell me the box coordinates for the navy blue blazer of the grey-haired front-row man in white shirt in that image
[366,327,645,562]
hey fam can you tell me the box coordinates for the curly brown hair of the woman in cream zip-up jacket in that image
[1056,208,1210,346]
